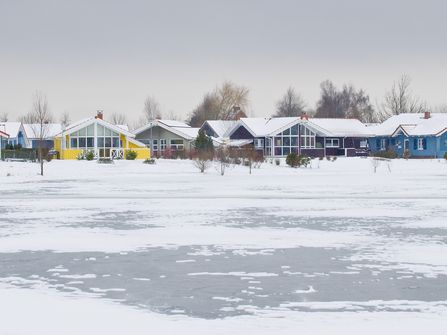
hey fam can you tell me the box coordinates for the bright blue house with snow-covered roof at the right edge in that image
[369,112,447,158]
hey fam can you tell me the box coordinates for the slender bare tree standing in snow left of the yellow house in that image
[24,91,52,176]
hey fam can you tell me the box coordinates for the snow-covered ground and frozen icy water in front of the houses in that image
[0,158,447,334]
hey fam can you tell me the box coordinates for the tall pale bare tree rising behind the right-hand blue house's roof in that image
[380,74,427,119]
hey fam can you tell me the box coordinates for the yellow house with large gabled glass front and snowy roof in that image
[54,112,150,159]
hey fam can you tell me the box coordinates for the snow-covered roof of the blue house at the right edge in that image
[368,113,447,136]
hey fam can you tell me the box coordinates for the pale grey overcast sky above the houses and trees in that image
[0,0,447,121]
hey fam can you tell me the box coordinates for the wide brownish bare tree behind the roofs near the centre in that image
[188,82,249,127]
